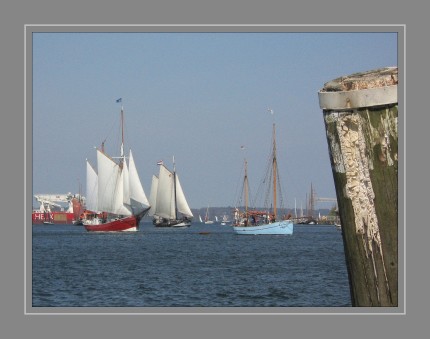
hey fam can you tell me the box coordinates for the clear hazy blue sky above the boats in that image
[30,32,398,208]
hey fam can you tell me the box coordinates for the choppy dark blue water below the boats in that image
[32,223,351,307]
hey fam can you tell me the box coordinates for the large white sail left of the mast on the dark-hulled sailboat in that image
[154,165,175,219]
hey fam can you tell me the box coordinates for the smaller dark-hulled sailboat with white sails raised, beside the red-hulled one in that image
[149,159,193,227]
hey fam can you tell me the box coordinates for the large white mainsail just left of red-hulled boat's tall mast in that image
[97,150,132,216]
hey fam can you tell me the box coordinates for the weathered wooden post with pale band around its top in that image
[318,67,398,307]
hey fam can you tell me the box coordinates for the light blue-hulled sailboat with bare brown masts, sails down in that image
[233,124,294,235]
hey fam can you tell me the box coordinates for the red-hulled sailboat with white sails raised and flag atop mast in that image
[82,99,150,232]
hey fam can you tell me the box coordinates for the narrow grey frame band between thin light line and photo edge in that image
[24,25,406,315]
